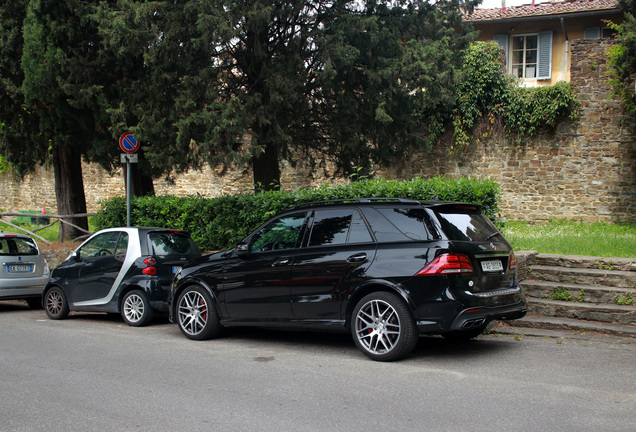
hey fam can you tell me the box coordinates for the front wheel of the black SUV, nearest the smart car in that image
[176,285,223,340]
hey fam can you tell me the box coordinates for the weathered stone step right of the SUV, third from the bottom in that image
[521,279,636,304]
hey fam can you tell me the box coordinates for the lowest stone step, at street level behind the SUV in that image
[491,315,636,338]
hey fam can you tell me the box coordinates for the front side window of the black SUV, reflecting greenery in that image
[250,212,307,252]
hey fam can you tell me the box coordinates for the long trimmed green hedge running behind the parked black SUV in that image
[93,177,500,251]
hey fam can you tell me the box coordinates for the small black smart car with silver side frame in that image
[42,227,201,326]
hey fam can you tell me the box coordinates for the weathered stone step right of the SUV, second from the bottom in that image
[528,297,636,326]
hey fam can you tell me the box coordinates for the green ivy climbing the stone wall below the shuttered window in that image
[450,42,579,152]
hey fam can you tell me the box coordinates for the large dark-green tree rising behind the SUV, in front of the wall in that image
[179,0,474,189]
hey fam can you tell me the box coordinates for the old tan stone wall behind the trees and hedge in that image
[0,39,636,223]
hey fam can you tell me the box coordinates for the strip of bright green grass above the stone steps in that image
[502,220,636,258]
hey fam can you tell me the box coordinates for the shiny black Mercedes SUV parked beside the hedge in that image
[169,198,526,361]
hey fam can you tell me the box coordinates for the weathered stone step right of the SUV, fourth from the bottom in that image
[524,265,636,288]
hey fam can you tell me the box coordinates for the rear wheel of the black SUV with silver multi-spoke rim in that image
[351,291,418,361]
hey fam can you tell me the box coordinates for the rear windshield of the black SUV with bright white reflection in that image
[435,208,499,242]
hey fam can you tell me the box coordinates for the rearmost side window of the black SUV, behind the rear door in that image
[363,207,439,243]
